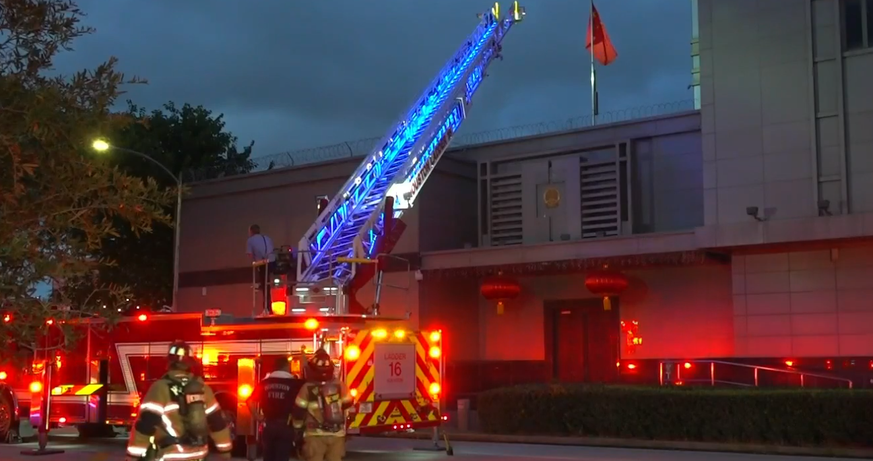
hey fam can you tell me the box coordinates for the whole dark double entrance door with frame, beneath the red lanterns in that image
[545,299,619,383]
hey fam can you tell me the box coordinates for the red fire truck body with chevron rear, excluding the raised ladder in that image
[4,311,444,454]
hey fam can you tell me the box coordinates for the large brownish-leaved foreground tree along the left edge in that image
[0,0,174,358]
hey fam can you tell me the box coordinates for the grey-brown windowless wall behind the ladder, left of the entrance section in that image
[179,158,476,316]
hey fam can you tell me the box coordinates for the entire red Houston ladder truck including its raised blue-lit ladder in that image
[0,1,525,457]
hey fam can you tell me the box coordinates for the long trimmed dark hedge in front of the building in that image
[478,385,873,447]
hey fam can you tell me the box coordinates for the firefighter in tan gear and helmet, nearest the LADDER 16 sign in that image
[295,349,353,461]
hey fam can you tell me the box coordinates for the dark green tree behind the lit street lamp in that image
[86,101,254,309]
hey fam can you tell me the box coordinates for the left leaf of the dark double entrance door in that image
[552,307,588,383]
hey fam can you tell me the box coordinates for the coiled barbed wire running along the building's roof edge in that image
[185,99,694,182]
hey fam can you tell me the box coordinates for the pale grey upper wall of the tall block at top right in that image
[698,0,873,225]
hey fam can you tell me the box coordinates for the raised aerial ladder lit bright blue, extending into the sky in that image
[297,1,524,285]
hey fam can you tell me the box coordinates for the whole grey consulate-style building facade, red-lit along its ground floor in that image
[179,0,873,395]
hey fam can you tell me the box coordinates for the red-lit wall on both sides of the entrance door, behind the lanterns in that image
[421,266,735,361]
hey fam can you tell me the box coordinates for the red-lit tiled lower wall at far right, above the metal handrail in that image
[732,246,873,357]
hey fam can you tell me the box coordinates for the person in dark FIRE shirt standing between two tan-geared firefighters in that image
[246,357,303,461]
